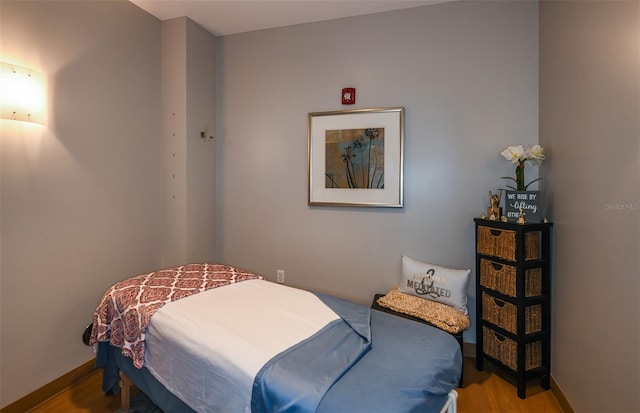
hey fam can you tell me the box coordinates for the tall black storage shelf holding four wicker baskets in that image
[475,218,552,399]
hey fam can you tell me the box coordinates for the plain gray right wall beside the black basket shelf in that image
[540,1,640,412]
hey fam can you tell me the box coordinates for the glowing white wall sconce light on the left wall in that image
[0,62,46,125]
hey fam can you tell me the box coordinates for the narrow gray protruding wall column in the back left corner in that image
[162,17,216,267]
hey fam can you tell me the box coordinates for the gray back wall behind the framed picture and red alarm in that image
[216,1,538,350]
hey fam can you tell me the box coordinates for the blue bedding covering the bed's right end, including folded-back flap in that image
[251,295,462,413]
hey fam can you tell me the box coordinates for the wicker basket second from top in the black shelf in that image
[480,258,542,297]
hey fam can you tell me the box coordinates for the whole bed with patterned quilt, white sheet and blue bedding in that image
[89,263,462,413]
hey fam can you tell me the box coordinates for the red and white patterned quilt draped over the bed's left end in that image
[89,263,263,368]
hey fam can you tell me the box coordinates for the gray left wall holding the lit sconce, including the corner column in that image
[0,0,215,406]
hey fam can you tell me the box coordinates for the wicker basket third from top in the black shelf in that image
[482,293,542,334]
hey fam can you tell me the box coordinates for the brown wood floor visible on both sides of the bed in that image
[30,358,562,413]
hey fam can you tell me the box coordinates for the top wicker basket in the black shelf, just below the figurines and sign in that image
[477,225,541,261]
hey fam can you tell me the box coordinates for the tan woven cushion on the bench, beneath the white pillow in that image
[378,288,471,334]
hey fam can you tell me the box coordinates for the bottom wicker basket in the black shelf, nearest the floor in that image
[482,327,542,371]
